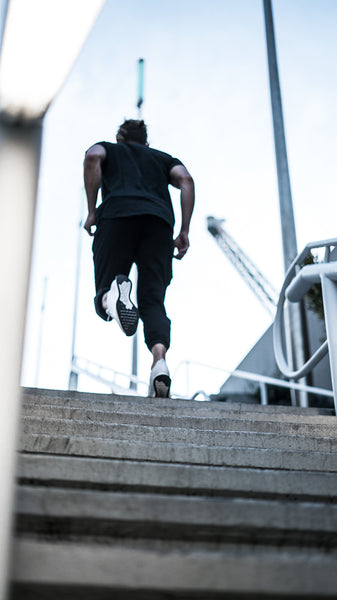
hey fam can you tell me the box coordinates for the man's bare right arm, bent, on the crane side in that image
[170,165,194,259]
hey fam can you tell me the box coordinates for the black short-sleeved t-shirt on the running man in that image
[96,142,182,227]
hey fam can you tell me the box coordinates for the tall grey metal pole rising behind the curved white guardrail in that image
[263,0,308,406]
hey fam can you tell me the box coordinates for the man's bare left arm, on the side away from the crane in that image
[84,144,106,235]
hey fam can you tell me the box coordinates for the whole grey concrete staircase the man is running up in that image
[10,389,337,600]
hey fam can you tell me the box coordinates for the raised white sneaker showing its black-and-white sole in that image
[106,275,139,336]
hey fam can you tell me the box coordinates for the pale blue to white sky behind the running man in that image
[19,0,337,392]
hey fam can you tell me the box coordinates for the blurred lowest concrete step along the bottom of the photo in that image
[12,538,337,600]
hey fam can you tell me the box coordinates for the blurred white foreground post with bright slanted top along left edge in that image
[0,0,104,600]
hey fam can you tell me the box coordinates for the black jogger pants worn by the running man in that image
[93,215,173,350]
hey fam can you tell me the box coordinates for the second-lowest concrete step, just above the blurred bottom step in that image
[16,485,337,551]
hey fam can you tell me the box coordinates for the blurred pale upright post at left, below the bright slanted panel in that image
[0,121,42,600]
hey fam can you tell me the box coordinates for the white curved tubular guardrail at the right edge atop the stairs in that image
[274,238,337,414]
